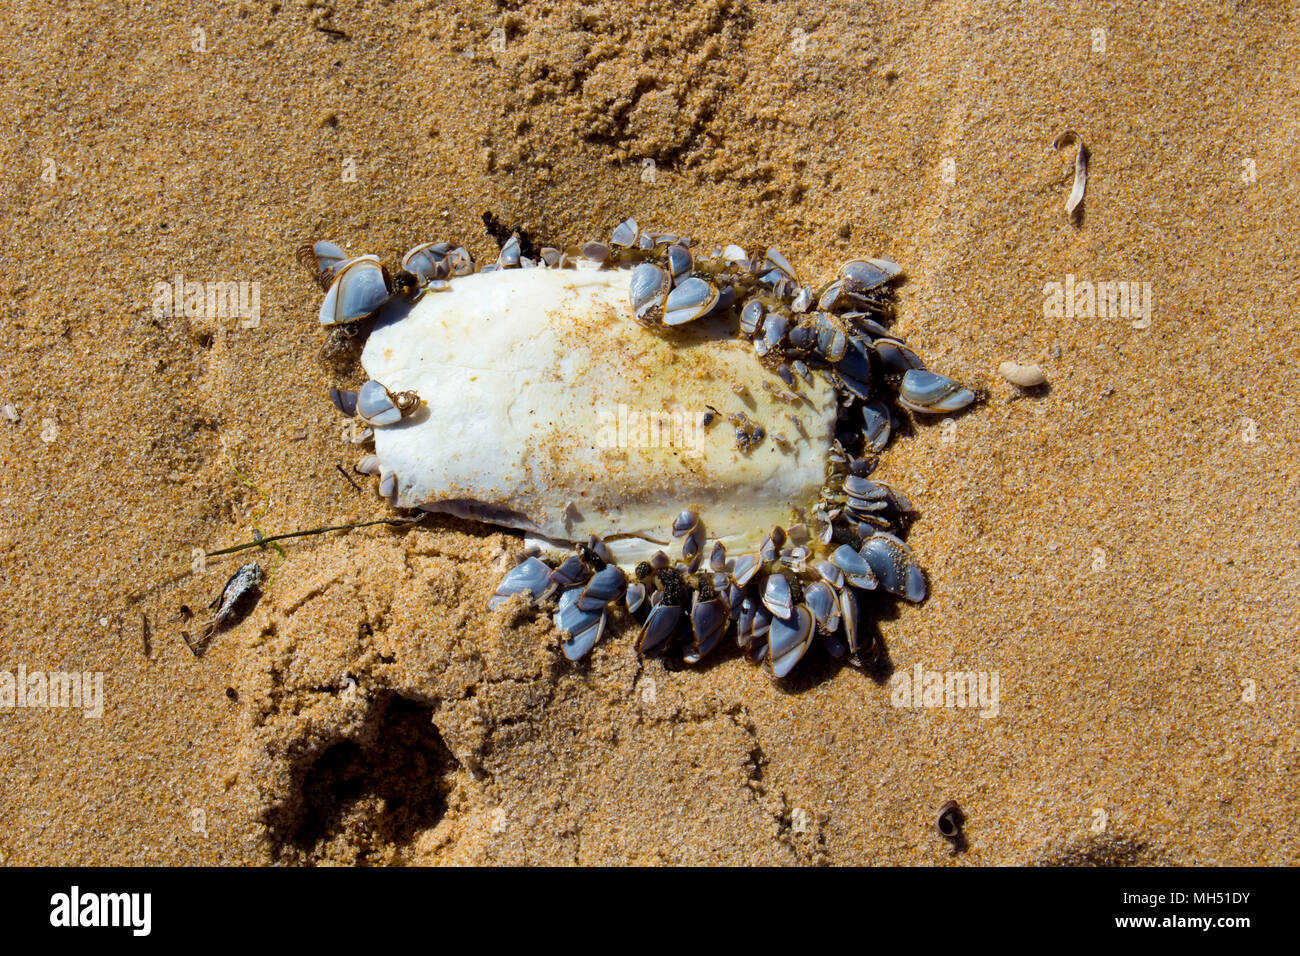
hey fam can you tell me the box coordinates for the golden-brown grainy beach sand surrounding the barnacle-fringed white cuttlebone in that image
[0,0,1300,866]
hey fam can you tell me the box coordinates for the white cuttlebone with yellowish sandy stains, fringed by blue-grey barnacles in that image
[361,269,836,566]
